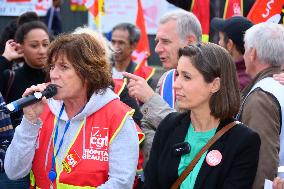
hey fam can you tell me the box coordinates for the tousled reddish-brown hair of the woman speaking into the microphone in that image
[46,33,112,99]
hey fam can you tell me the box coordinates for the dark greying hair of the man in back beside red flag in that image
[112,23,141,45]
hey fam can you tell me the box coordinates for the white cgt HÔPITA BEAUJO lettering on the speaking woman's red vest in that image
[82,127,108,161]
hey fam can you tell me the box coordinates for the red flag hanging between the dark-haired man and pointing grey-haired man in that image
[132,0,150,66]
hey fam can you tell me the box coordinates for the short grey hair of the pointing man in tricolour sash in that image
[160,10,202,42]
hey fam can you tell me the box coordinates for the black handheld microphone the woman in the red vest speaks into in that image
[3,84,57,113]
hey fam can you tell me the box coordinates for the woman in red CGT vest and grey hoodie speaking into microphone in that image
[5,34,138,189]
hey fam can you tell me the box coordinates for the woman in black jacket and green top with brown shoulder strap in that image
[144,43,260,189]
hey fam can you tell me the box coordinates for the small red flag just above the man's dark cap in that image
[223,0,243,19]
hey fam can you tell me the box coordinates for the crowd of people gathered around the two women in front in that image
[0,1,284,189]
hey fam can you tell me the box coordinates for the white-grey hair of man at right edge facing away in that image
[244,22,284,66]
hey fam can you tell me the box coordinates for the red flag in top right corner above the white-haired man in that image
[247,0,284,24]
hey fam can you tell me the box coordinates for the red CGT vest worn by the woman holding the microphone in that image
[31,99,135,189]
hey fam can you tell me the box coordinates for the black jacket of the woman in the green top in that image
[144,113,260,189]
